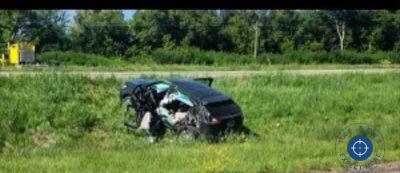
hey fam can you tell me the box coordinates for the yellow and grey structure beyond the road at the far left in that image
[0,43,36,65]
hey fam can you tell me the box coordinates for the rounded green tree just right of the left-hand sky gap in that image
[71,10,132,55]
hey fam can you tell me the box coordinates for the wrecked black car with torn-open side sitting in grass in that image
[120,78,243,141]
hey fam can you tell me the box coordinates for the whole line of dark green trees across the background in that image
[0,10,400,57]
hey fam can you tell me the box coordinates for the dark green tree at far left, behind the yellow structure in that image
[0,10,68,51]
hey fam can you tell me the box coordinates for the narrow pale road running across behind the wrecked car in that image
[0,68,400,78]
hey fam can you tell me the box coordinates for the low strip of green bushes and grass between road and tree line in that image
[38,48,400,67]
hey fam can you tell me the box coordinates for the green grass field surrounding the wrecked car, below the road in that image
[0,73,400,172]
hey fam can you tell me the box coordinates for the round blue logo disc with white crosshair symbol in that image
[347,135,374,161]
